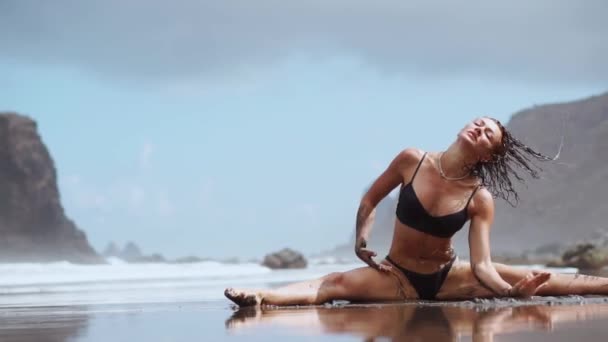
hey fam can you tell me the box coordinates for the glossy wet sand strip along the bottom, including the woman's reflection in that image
[0,296,608,342]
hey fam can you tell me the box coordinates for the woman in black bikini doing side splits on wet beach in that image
[225,117,608,306]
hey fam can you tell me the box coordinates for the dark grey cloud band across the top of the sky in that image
[0,0,608,83]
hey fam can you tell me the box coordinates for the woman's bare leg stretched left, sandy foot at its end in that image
[224,267,410,306]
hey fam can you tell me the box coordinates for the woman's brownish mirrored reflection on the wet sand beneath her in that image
[226,304,608,341]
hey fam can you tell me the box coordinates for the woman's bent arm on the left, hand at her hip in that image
[355,148,420,268]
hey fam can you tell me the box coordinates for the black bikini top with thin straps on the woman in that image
[397,153,479,238]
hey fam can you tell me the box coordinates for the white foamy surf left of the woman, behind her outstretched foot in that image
[0,259,361,308]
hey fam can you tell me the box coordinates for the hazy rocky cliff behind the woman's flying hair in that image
[329,93,608,257]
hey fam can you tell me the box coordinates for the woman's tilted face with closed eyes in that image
[458,117,502,160]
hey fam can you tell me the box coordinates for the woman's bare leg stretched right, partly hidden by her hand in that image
[437,262,608,299]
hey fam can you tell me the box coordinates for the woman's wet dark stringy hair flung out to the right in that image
[471,118,561,206]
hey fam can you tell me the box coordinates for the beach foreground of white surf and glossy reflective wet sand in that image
[0,262,608,342]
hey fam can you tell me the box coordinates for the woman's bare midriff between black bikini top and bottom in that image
[389,221,454,273]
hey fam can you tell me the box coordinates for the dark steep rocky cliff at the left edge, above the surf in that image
[0,113,102,263]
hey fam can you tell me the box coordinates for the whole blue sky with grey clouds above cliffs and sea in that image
[0,0,608,257]
